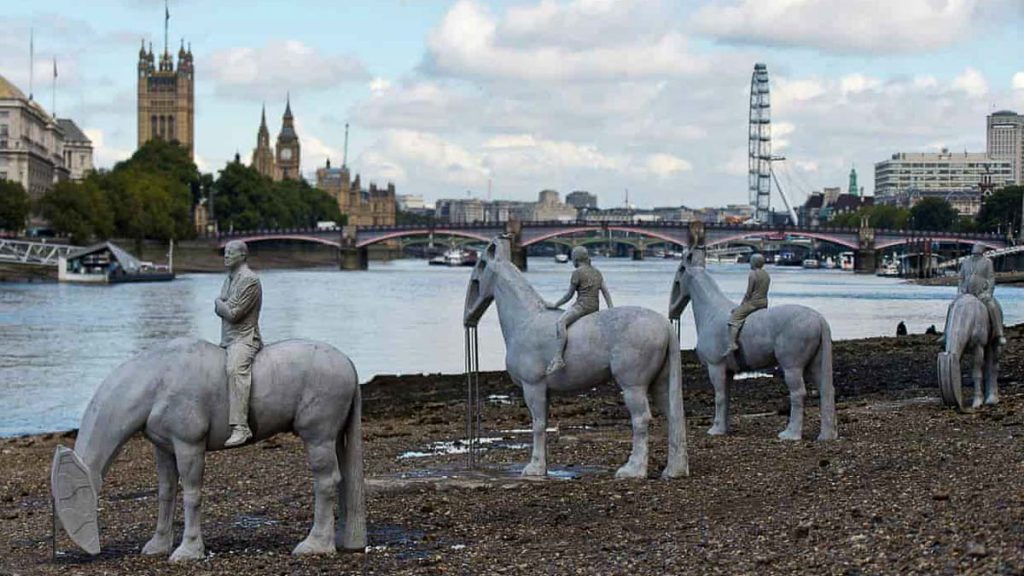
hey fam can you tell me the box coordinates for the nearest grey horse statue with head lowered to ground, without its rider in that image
[51,338,367,562]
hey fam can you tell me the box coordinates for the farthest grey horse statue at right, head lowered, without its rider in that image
[938,293,1001,410]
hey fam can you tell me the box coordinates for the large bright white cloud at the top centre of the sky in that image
[425,0,708,81]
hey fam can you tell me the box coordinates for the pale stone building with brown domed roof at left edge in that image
[0,76,71,203]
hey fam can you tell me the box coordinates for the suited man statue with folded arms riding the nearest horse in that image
[214,240,263,448]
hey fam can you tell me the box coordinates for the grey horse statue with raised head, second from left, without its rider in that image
[464,238,689,478]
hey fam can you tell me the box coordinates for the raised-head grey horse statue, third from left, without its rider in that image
[669,248,838,440]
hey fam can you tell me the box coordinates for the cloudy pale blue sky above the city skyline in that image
[0,0,1024,209]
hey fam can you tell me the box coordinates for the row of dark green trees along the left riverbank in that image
[0,139,344,244]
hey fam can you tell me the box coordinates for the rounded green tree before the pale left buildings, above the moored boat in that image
[39,175,114,244]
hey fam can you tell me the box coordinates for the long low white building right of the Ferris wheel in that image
[874,149,1014,199]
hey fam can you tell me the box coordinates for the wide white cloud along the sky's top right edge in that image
[692,0,1020,53]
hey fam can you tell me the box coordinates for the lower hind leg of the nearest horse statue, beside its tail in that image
[292,439,341,556]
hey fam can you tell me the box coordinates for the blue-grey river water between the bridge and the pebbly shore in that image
[0,258,1024,436]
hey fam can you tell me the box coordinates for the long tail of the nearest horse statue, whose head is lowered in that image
[336,366,367,550]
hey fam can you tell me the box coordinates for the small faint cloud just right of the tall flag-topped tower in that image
[205,40,370,99]
